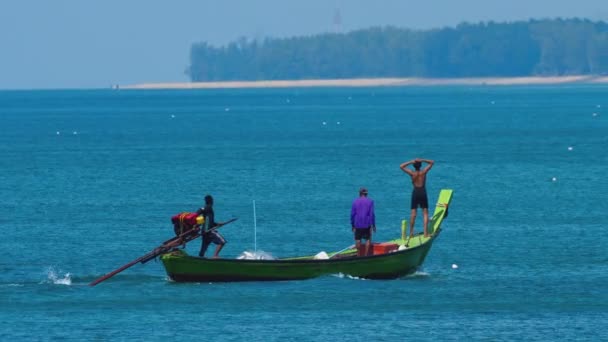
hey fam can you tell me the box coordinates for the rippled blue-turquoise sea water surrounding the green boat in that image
[0,86,608,341]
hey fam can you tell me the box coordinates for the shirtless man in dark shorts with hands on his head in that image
[400,158,434,237]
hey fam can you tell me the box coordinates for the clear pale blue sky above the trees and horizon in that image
[0,0,608,89]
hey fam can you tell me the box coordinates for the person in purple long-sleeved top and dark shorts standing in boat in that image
[350,188,376,256]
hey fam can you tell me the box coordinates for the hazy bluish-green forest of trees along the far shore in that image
[186,19,608,82]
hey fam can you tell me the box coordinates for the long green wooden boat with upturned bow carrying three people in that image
[160,189,452,282]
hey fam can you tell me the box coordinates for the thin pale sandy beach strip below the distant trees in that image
[119,75,608,89]
